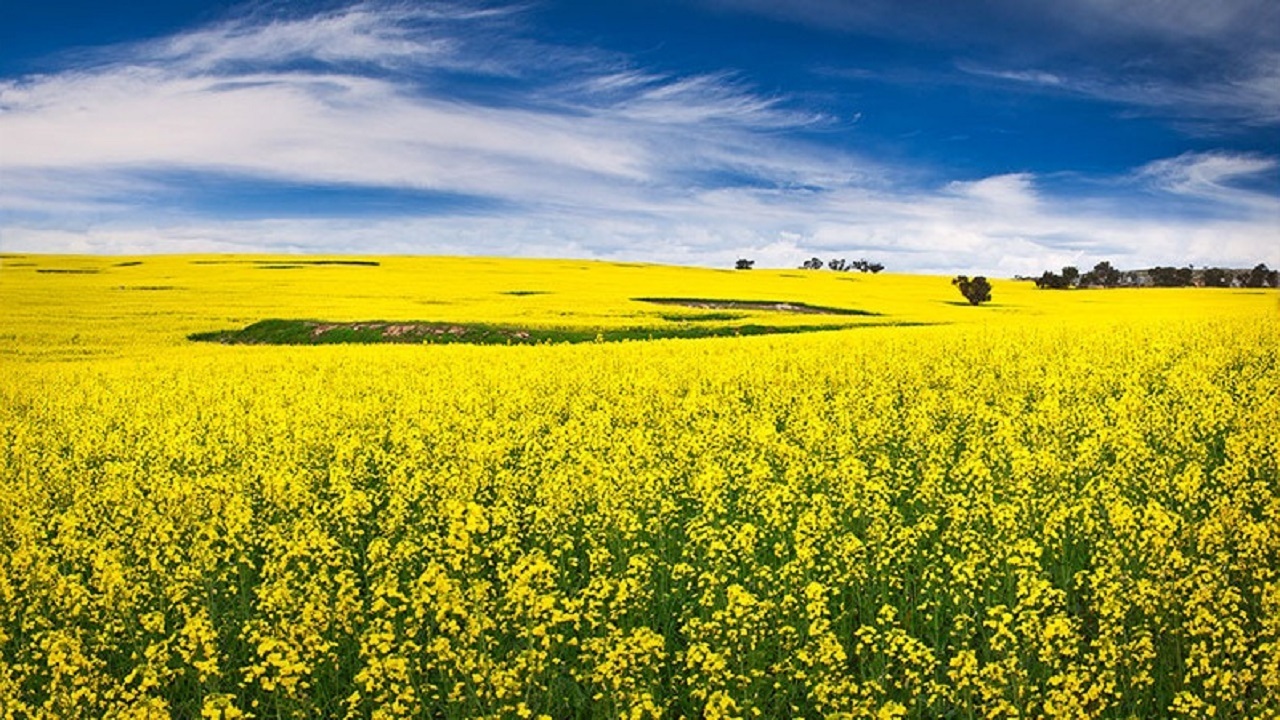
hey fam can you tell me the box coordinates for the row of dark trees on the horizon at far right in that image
[1021,260,1280,290]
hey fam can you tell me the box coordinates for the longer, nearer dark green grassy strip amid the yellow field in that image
[187,319,885,345]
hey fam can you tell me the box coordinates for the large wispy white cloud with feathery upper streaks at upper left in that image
[0,5,829,202]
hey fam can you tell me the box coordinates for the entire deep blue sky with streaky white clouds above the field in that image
[0,0,1280,275]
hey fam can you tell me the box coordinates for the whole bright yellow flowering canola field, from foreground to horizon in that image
[0,255,1280,720]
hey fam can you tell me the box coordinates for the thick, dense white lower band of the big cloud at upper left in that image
[0,68,644,196]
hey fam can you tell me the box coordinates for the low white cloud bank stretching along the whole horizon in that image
[3,163,1280,277]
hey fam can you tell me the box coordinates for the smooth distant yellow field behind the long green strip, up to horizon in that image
[0,254,1276,361]
